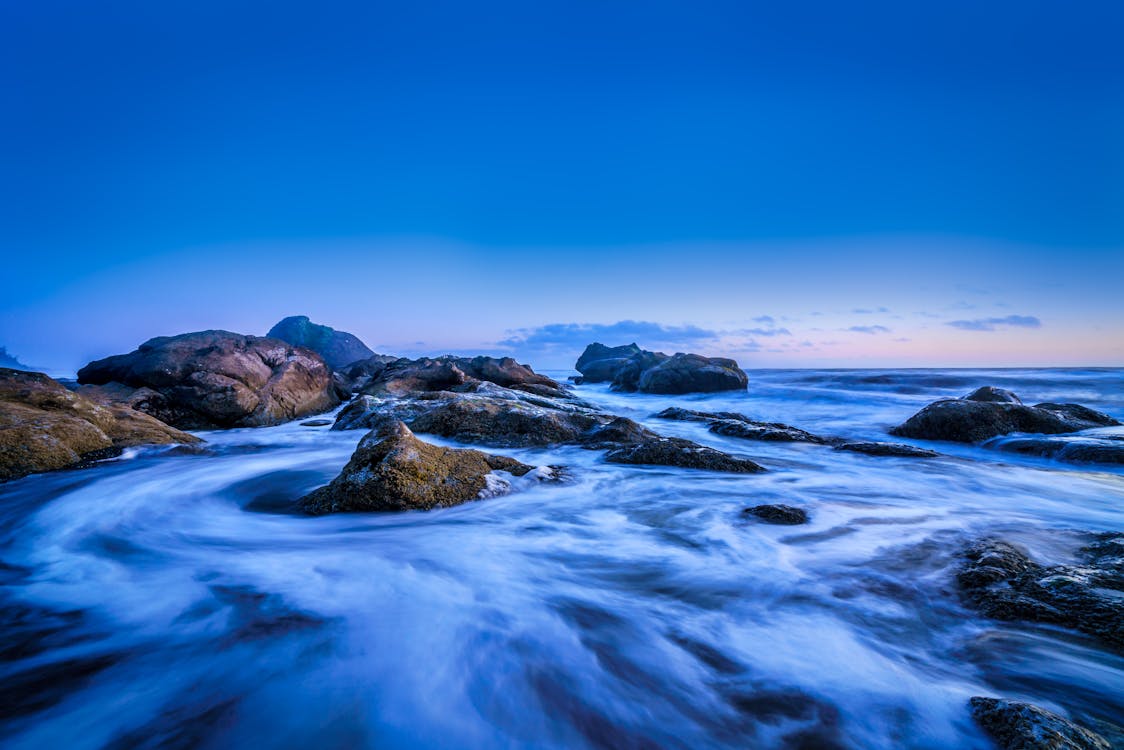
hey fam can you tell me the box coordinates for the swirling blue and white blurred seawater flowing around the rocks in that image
[0,370,1124,750]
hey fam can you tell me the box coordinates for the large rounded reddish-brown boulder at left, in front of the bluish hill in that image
[78,331,339,430]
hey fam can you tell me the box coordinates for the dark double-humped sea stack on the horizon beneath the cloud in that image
[574,343,749,394]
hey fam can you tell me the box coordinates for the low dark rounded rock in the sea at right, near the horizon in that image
[890,389,1120,443]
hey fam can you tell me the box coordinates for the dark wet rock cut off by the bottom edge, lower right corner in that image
[969,696,1112,750]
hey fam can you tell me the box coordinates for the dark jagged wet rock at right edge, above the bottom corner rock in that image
[957,533,1124,652]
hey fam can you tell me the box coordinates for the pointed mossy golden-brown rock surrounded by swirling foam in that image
[300,422,552,515]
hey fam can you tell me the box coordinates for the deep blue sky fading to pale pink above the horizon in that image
[0,0,1124,371]
